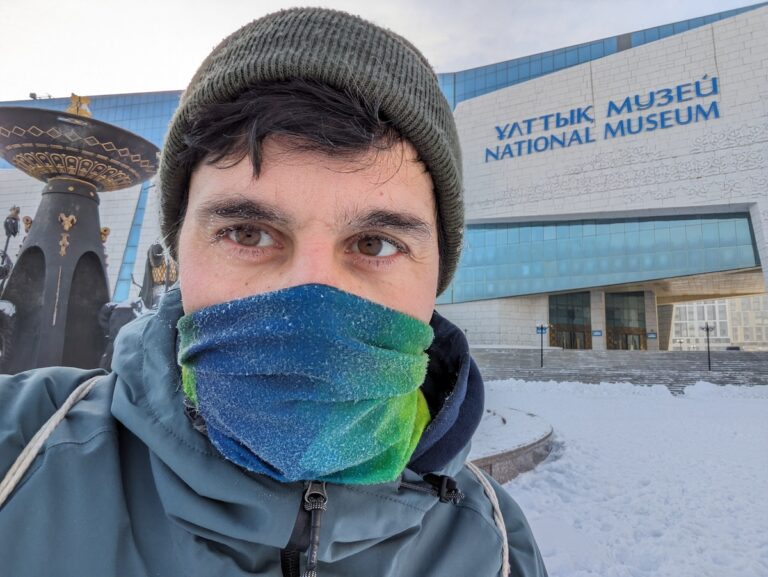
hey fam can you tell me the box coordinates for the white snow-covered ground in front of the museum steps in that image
[486,380,768,577]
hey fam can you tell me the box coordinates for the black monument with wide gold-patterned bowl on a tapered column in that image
[0,107,158,373]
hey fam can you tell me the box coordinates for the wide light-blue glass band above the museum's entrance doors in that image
[438,213,760,304]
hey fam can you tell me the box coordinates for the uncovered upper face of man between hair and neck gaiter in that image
[178,138,439,322]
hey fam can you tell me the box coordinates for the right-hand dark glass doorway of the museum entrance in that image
[605,292,648,351]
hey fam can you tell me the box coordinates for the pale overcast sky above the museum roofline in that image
[0,0,756,101]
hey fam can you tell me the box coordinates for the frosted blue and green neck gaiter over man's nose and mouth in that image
[178,284,434,484]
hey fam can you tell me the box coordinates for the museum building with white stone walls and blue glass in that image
[0,2,768,350]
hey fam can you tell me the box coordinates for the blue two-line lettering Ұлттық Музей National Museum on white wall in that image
[485,74,720,162]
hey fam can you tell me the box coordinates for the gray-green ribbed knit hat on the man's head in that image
[159,8,464,294]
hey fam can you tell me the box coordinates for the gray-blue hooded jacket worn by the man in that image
[0,291,546,577]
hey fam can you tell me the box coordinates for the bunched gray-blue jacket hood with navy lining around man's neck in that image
[112,288,483,566]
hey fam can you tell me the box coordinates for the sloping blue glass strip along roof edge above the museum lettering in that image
[438,2,768,108]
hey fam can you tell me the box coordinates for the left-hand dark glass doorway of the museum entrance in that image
[549,292,592,349]
